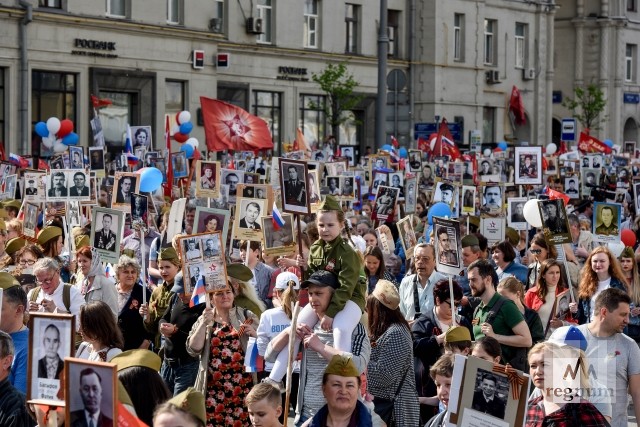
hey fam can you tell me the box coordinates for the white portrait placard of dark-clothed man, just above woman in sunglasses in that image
[91,205,124,264]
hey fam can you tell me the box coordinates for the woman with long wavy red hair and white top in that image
[569,246,628,325]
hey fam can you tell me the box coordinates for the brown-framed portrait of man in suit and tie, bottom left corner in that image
[64,357,118,427]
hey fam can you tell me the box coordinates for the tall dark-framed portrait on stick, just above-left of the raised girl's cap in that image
[280,158,311,215]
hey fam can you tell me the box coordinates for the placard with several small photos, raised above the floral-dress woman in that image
[178,231,228,295]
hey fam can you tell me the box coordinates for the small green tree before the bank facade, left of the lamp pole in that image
[310,63,363,144]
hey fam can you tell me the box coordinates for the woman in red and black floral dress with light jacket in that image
[187,276,258,427]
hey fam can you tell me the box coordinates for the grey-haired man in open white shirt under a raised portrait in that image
[400,243,446,323]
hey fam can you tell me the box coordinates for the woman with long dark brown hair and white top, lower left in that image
[76,301,124,362]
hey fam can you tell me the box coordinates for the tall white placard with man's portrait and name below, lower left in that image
[27,312,76,406]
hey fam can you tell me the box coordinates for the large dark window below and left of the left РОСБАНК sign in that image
[31,71,77,129]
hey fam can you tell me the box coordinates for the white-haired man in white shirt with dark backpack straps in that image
[27,258,84,327]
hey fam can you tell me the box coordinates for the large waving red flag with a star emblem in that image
[200,96,273,151]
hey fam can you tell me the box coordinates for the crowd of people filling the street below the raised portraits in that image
[0,145,640,427]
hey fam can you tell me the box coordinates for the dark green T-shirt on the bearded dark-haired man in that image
[473,292,524,362]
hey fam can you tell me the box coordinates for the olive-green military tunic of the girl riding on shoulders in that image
[305,237,367,317]
